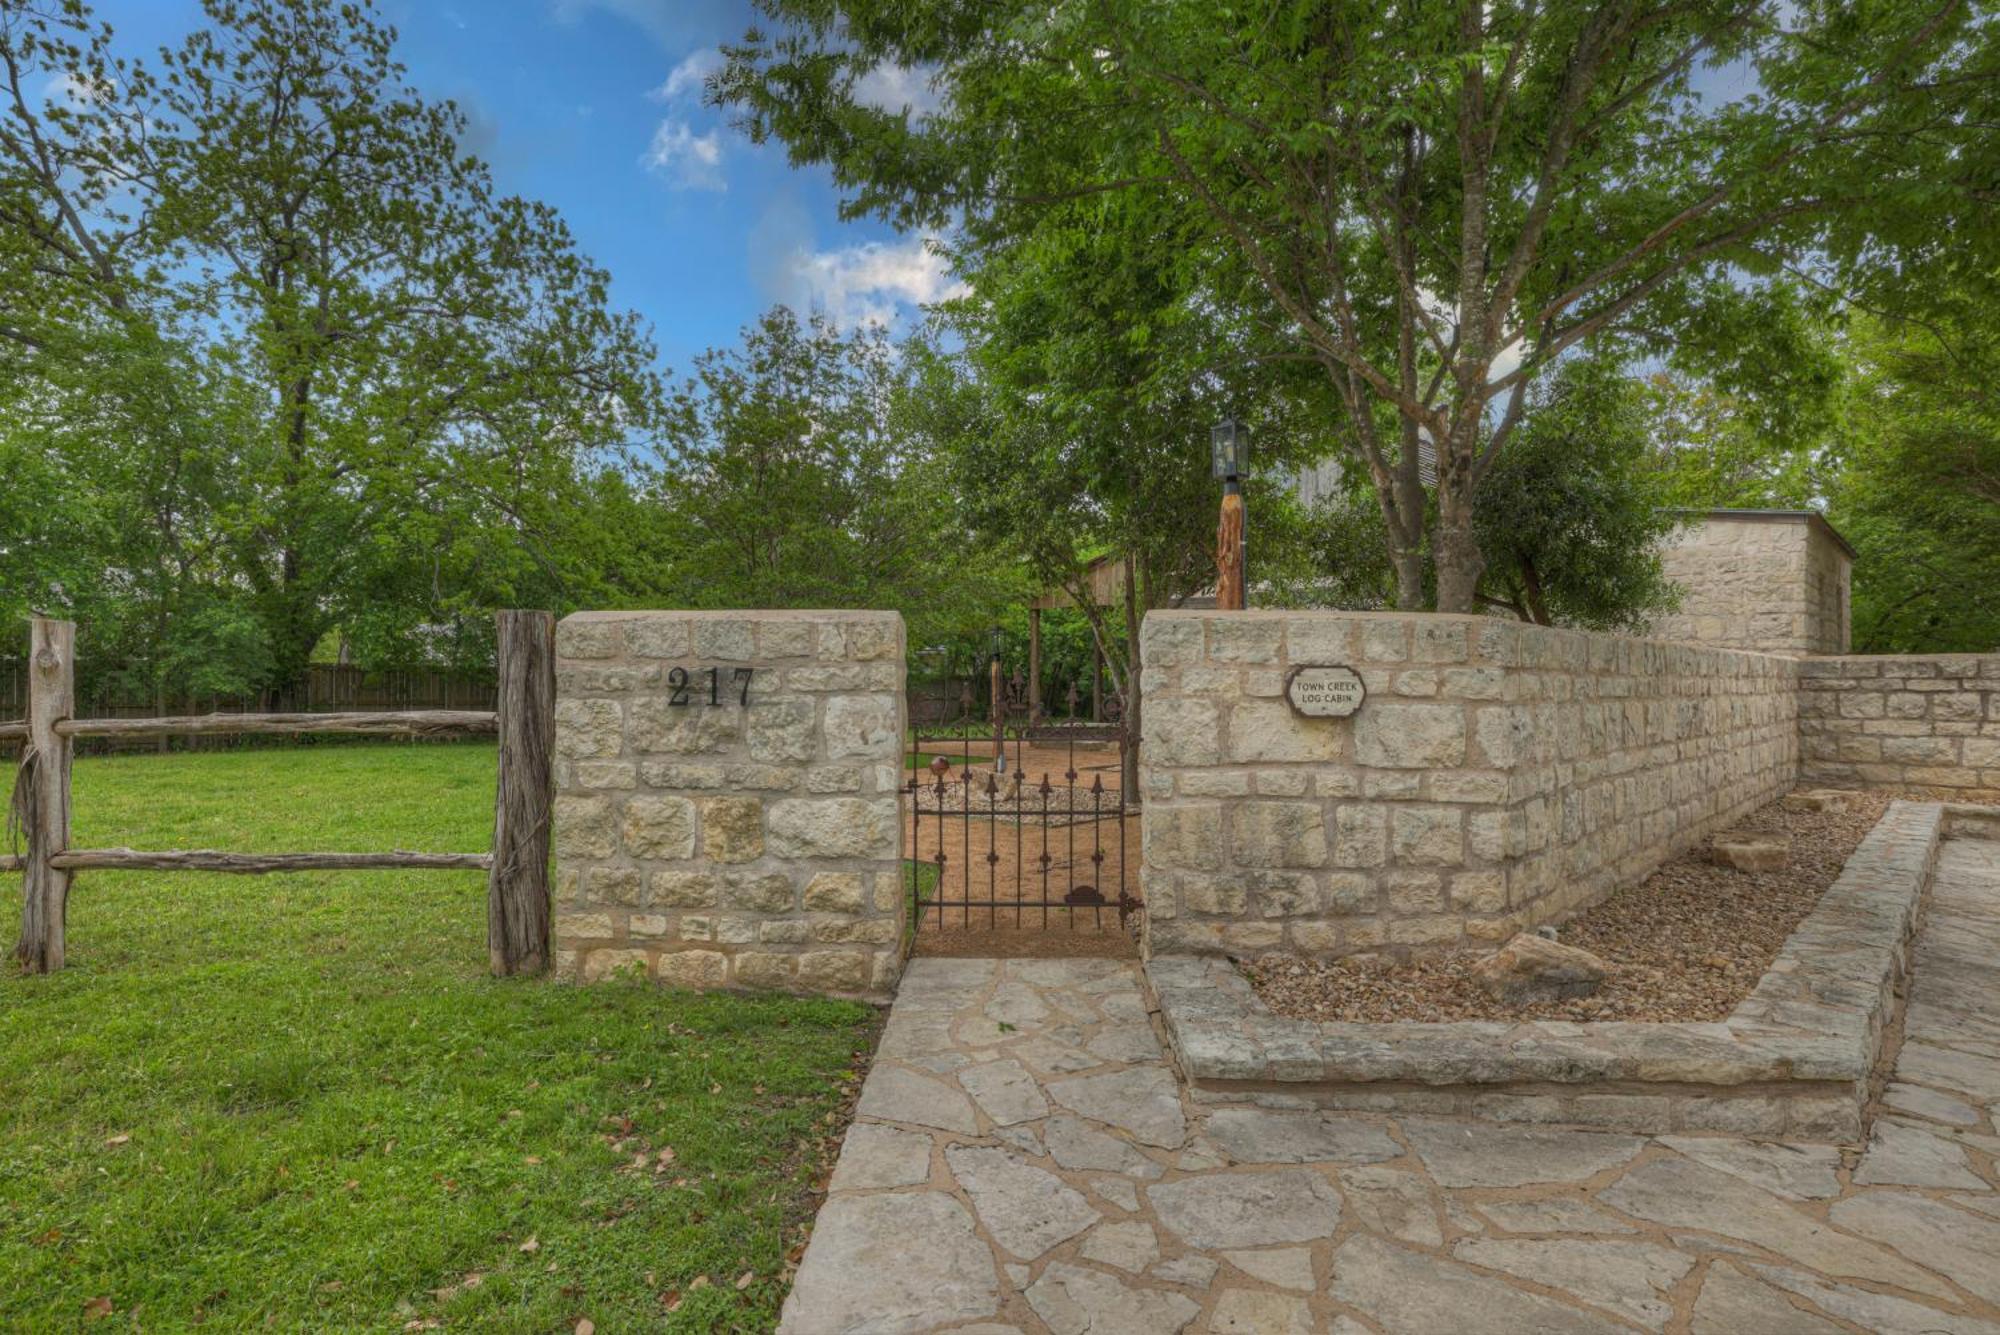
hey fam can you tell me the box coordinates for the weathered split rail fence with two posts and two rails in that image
[0,612,556,975]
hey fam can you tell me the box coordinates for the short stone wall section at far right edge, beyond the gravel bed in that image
[1798,654,2000,787]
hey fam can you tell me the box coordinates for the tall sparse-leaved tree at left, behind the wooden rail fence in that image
[0,0,658,683]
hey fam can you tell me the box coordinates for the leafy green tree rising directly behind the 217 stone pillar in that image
[652,306,1012,640]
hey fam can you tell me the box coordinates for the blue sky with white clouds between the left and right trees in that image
[96,0,948,372]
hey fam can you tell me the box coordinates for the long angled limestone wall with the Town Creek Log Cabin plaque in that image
[1140,612,1798,955]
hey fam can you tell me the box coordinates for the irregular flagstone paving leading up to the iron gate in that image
[780,839,2000,1335]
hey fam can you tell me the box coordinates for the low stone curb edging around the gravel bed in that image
[1146,801,1956,1141]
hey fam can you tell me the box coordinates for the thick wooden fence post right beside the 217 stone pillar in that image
[486,612,556,975]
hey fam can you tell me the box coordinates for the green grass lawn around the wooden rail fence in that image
[0,745,874,1335]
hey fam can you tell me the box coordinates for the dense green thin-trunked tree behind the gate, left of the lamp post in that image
[918,188,1328,793]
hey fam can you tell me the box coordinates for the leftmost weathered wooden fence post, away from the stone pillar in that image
[14,618,76,973]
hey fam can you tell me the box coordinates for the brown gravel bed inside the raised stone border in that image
[1244,791,1892,1021]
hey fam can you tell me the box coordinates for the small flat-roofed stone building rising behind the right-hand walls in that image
[1652,510,1854,654]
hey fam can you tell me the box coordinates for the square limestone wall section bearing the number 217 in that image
[554,612,904,999]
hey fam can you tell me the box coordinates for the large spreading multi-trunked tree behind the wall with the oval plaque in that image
[714,0,1994,612]
